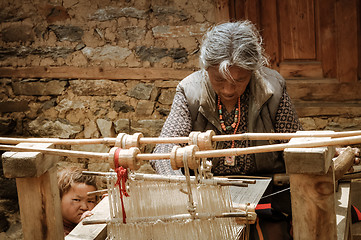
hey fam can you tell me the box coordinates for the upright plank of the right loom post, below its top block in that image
[290,170,337,240]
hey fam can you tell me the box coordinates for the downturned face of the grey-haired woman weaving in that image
[207,66,252,108]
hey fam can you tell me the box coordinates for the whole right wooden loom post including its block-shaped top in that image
[284,133,337,240]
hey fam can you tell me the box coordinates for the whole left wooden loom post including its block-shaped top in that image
[2,143,64,240]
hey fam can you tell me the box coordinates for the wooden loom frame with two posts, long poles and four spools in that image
[0,132,361,239]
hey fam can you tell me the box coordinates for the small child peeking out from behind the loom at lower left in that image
[58,167,97,236]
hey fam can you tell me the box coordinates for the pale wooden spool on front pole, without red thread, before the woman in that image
[170,145,200,170]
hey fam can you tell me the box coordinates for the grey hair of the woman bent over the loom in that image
[199,21,268,77]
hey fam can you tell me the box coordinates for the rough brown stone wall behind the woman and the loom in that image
[0,0,361,239]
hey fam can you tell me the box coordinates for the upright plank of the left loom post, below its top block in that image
[16,167,64,240]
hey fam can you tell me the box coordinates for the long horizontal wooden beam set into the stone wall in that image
[0,66,193,80]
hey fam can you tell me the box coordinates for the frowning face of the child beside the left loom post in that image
[61,183,96,224]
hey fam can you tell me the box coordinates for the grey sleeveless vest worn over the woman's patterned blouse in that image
[177,67,285,174]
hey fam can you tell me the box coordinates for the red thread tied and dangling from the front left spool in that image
[114,148,129,223]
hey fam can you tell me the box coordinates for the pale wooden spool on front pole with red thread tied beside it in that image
[108,147,141,170]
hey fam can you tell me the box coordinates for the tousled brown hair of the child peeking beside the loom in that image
[58,167,98,199]
